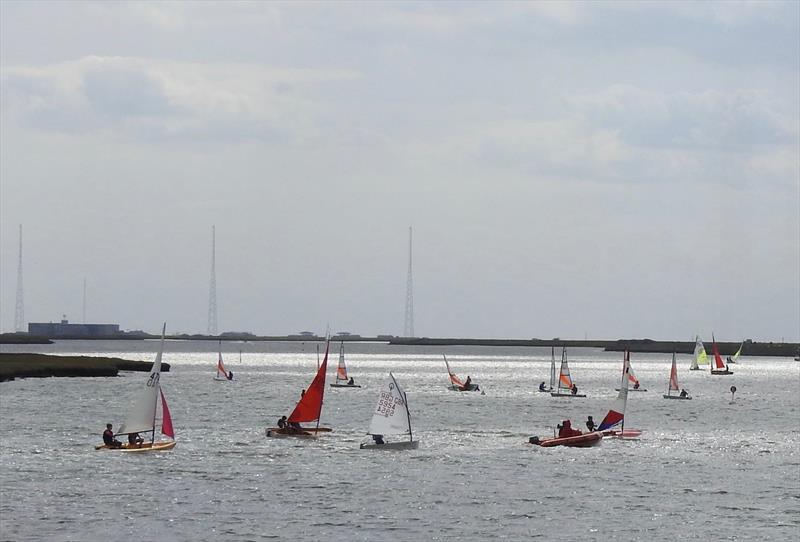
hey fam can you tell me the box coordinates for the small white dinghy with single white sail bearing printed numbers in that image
[360,373,419,450]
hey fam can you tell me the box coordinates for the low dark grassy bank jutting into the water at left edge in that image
[0,353,169,382]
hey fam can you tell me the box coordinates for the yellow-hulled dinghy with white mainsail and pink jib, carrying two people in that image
[94,323,175,452]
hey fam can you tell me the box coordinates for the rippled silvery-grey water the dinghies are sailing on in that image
[0,341,800,541]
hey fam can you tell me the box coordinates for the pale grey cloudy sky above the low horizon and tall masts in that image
[0,1,800,341]
